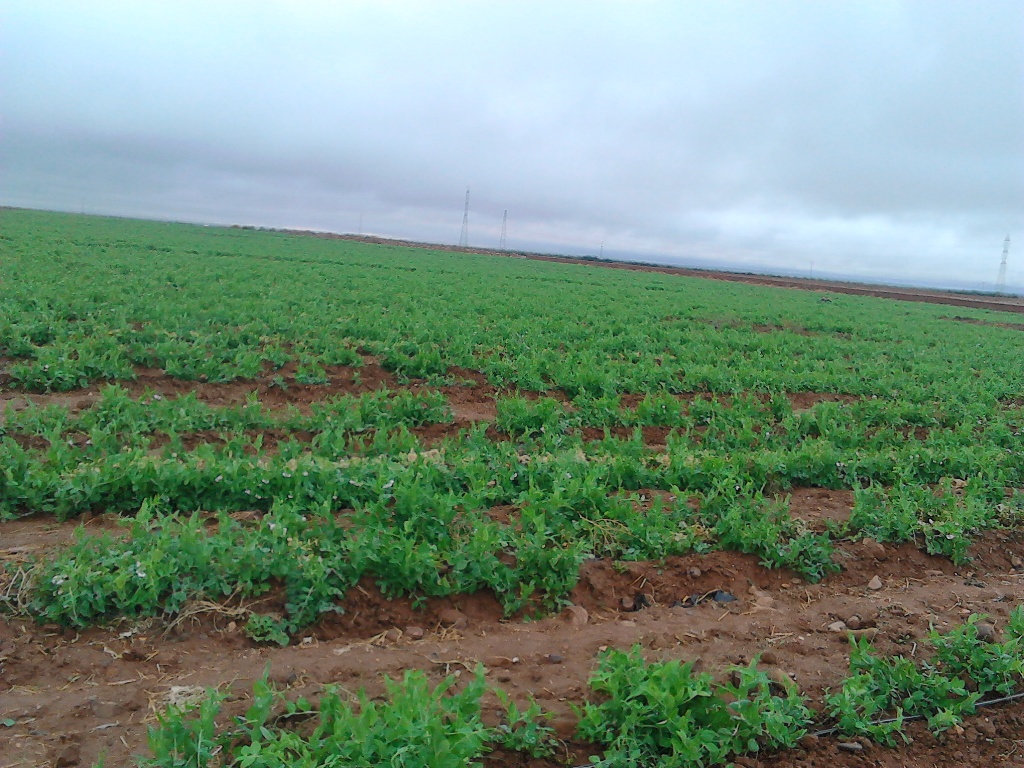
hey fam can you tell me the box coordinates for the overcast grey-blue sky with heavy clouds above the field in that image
[0,0,1024,288]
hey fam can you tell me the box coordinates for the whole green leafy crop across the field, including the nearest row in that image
[0,210,1024,766]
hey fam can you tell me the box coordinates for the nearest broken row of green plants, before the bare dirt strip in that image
[134,606,1024,768]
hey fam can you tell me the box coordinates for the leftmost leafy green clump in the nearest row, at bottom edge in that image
[141,668,554,768]
